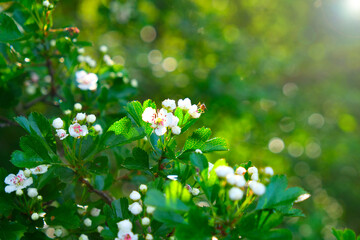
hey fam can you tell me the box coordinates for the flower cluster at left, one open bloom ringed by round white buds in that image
[52,103,102,140]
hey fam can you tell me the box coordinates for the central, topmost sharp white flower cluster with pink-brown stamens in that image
[142,98,201,136]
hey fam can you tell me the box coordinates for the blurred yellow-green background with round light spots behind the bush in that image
[1,0,360,240]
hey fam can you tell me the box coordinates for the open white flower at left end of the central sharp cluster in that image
[142,107,173,136]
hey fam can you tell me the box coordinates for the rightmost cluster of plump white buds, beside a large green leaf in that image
[215,166,274,201]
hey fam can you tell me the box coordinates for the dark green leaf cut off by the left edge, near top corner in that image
[0,13,23,42]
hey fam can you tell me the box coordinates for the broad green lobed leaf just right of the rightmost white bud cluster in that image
[256,175,306,214]
